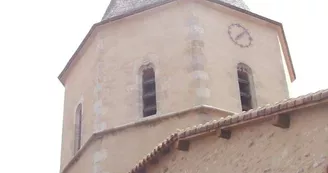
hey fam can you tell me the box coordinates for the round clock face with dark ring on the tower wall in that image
[228,24,253,48]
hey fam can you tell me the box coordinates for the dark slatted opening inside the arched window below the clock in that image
[238,70,252,111]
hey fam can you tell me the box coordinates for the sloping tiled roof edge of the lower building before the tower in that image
[129,89,328,173]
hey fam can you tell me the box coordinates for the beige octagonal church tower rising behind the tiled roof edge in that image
[59,0,295,173]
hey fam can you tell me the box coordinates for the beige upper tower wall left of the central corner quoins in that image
[61,1,192,167]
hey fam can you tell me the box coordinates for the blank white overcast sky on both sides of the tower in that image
[0,0,328,173]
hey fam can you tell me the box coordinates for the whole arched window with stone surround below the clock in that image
[237,63,255,111]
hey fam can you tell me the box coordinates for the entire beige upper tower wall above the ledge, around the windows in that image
[61,1,288,168]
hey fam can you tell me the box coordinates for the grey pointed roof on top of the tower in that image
[102,0,249,20]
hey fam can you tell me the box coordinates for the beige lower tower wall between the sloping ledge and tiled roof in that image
[65,110,228,173]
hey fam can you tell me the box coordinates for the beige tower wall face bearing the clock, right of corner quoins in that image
[190,1,289,112]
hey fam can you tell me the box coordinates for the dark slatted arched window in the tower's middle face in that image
[142,67,157,117]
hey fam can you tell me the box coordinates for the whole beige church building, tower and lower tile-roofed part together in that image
[58,0,328,173]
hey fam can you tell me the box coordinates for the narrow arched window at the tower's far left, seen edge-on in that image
[74,103,82,153]
